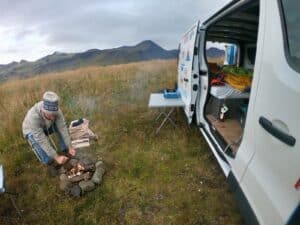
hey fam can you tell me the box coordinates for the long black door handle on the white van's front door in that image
[259,116,296,146]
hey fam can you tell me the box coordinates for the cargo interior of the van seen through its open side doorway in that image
[204,1,259,157]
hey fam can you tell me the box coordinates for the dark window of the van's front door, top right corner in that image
[282,0,300,71]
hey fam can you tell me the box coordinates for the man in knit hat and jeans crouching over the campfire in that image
[22,91,76,165]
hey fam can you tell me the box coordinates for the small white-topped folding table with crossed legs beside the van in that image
[148,93,184,134]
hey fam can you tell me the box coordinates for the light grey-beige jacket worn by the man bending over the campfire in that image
[22,101,71,158]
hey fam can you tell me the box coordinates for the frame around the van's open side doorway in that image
[196,0,263,178]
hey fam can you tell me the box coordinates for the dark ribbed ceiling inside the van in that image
[201,0,259,43]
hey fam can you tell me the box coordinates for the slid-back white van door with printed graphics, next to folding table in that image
[178,22,200,123]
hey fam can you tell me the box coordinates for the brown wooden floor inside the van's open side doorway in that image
[207,115,243,155]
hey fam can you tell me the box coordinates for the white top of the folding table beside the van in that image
[148,93,184,108]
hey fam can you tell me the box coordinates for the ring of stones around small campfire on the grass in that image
[59,158,105,197]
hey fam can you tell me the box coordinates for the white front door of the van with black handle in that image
[241,0,300,225]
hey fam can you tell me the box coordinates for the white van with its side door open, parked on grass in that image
[178,0,300,225]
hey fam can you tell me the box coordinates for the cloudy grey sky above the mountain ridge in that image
[0,0,229,64]
